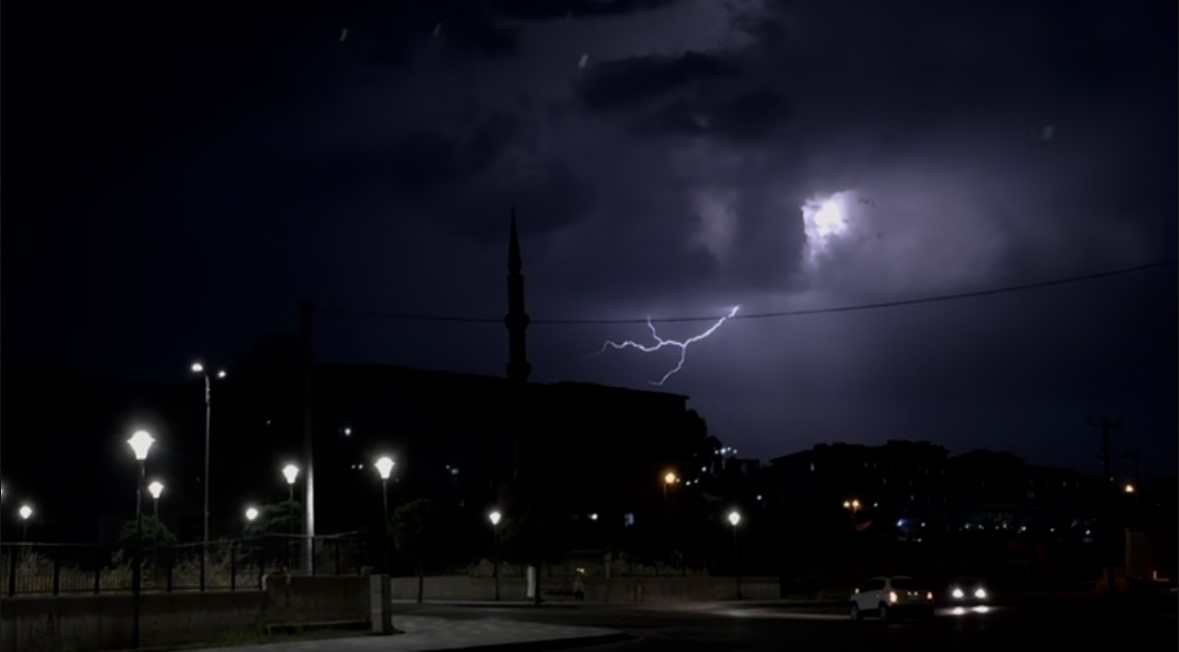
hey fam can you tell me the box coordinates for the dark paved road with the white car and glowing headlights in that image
[395,599,1179,652]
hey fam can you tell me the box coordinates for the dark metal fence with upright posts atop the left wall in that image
[0,533,368,597]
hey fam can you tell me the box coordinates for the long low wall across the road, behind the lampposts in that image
[393,575,782,604]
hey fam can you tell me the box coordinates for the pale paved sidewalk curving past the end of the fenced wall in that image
[181,614,628,652]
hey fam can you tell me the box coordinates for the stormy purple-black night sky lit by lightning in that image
[2,0,1179,473]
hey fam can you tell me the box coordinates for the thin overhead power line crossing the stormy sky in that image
[320,258,1179,325]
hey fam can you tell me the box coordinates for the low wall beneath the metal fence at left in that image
[0,577,370,652]
